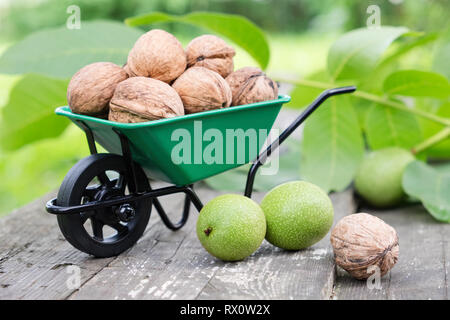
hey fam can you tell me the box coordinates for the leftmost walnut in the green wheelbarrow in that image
[67,62,128,117]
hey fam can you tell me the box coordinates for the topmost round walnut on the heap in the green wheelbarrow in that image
[126,29,186,83]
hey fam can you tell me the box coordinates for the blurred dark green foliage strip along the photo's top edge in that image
[0,0,450,41]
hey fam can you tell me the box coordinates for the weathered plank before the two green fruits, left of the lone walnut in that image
[198,190,356,300]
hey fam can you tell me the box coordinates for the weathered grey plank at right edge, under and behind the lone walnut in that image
[333,205,450,299]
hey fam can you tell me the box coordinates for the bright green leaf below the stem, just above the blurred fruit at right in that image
[365,104,422,149]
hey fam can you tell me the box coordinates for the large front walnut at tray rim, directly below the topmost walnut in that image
[109,77,184,123]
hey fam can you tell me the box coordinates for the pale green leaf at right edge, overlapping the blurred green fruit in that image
[403,161,450,223]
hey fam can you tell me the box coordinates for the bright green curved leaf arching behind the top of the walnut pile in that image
[125,12,270,69]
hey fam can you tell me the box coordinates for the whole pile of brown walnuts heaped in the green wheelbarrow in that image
[67,29,278,123]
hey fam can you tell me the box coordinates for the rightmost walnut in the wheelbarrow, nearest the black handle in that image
[226,67,278,106]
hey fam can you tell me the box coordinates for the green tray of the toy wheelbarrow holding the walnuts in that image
[56,96,290,186]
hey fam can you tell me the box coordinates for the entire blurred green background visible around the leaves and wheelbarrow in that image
[0,0,450,215]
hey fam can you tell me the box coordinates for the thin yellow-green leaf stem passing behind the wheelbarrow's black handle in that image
[273,78,450,126]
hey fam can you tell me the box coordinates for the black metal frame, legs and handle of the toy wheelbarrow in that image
[46,86,356,230]
